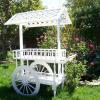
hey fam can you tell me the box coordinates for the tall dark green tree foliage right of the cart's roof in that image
[68,0,100,43]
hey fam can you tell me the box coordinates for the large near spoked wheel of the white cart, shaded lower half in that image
[12,66,40,96]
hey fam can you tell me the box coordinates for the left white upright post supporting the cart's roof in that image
[19,25,23,65]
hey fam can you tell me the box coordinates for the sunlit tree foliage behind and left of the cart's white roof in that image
[0,0,43,50]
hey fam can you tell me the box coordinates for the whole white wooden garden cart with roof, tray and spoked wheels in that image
[5,8,75,96]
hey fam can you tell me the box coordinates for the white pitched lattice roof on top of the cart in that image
[5,8,71,27]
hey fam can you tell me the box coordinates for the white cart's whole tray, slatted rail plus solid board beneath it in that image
[13,48,66,63]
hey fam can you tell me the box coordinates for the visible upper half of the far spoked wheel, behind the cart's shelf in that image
[30,61,53,74]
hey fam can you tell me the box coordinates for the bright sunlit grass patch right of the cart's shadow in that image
[53,86,100,100]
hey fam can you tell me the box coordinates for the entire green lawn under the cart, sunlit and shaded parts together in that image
[0,64,100,100]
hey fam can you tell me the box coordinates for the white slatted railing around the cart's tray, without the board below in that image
[13,49,66,59]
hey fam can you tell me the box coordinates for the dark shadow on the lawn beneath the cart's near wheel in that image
[0,85,52,100]
